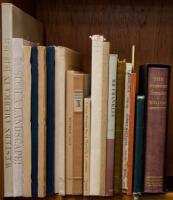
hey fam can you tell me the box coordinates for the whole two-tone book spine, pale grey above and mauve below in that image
[105,54,118,196]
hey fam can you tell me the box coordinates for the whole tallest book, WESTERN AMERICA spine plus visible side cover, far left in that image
[1,3,43,197]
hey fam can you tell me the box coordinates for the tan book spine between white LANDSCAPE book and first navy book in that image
[23,46,31,197]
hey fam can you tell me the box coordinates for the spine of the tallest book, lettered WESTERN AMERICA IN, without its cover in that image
[1,4,13,197]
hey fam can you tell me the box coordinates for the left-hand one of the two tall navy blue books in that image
[31,47,38,196]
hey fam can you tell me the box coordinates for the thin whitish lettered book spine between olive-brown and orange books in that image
[122,63,132,191]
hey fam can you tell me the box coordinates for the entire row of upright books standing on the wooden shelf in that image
[1,4,171,197]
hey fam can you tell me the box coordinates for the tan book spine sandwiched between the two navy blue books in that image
[37,46,47,197]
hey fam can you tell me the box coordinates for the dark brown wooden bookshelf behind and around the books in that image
[0,0,173,200]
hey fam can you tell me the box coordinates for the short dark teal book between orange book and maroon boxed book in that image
[133,95,145,193]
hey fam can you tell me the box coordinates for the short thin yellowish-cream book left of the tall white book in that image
[83,98,91,196]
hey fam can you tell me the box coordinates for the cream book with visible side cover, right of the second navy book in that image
[55,46,80,195]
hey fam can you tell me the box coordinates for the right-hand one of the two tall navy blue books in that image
[46,47,55,195]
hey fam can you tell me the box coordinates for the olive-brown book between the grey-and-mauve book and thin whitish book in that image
[114,60,126,193]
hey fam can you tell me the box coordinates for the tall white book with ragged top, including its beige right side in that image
[90,35,110,195]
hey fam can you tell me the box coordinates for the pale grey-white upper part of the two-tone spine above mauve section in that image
[107,54,118,139]
